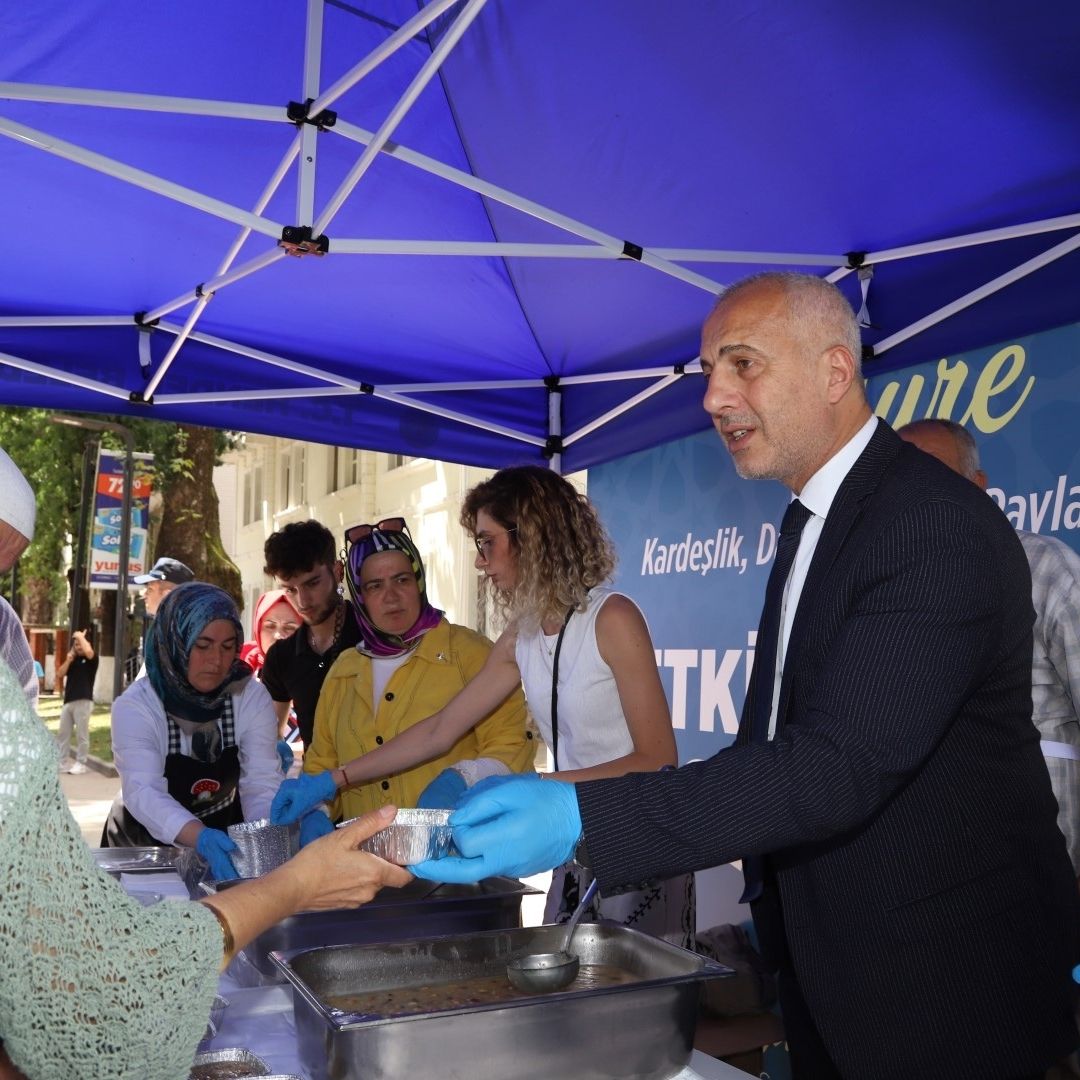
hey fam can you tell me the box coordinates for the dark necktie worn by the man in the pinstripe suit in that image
[742,499,813,903]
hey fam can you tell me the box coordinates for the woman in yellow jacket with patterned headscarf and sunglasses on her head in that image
[271,517,534,845]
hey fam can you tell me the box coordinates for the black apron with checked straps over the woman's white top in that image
[102,694,244,848]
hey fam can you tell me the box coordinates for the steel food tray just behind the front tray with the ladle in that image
[201,877,538,986]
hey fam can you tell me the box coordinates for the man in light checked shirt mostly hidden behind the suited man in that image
[896,420,1080,883]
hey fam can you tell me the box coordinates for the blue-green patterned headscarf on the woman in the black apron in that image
[146,581,252,724]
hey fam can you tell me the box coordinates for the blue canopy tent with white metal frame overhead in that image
[0,0,1080,471]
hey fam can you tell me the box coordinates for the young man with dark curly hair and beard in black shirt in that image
[261,521,360,746]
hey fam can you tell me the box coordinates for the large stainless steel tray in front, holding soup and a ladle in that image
[271,923,732,1080]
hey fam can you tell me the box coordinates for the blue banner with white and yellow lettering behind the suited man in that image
[589,315,1080,762]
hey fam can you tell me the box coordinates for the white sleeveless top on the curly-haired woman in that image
[514,585,634,769]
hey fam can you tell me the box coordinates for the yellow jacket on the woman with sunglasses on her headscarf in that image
[303,619,536,818]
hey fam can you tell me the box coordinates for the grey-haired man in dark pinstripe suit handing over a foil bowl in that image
[418,274,1080,1080]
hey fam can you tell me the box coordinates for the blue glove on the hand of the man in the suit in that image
[408,777,581,883]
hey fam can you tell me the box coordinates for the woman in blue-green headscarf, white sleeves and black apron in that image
[103,581,281,880]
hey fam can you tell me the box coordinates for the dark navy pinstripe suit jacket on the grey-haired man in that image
[578,422,1080,1080]
